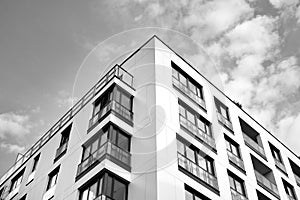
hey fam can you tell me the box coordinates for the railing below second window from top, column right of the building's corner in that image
[179,115,216,149]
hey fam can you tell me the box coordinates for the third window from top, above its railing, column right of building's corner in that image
[177,140,215,176]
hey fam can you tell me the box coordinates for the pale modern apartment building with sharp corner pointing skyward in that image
[0,36,300,200]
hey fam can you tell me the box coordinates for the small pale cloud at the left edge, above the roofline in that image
[0,112,32,138]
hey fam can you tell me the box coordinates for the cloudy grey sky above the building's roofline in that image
[0,0,300,175]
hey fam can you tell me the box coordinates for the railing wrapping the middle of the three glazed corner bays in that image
[77,142,131,176]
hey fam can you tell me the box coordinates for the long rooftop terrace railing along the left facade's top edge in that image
[0,65,133,185]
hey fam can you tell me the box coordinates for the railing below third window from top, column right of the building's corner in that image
[177,153,219,190]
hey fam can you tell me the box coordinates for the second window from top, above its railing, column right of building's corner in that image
[179,101,212,136]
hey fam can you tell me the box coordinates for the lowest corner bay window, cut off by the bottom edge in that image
[80,173,127,200]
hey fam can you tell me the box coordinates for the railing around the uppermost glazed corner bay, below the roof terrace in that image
[89,100,133,128]
